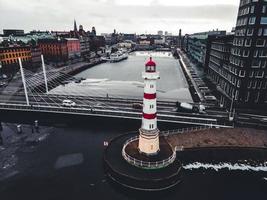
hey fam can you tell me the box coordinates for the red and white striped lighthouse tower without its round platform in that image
[138,57,160,156]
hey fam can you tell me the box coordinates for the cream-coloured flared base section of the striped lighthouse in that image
[138,129,160,156]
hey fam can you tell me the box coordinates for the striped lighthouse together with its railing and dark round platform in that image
[104,55,182,192]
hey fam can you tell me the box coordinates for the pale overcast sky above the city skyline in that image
[0,0,239,35]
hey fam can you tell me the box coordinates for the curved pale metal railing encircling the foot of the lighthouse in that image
[122,136,176,169]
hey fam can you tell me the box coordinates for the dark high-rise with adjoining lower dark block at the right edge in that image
[206,0,267,108]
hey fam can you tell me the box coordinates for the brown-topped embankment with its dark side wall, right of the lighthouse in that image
[167,128,267,164]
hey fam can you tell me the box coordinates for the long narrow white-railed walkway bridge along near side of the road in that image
[0,98,231,127]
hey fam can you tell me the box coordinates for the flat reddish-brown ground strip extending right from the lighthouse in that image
[167,128,267,149]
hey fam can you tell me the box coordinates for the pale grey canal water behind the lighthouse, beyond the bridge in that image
[50,51,192,102]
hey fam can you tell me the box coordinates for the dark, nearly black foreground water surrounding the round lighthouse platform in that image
[0,120,267,200]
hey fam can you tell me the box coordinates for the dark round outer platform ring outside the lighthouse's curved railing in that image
[104,134,181,191]
